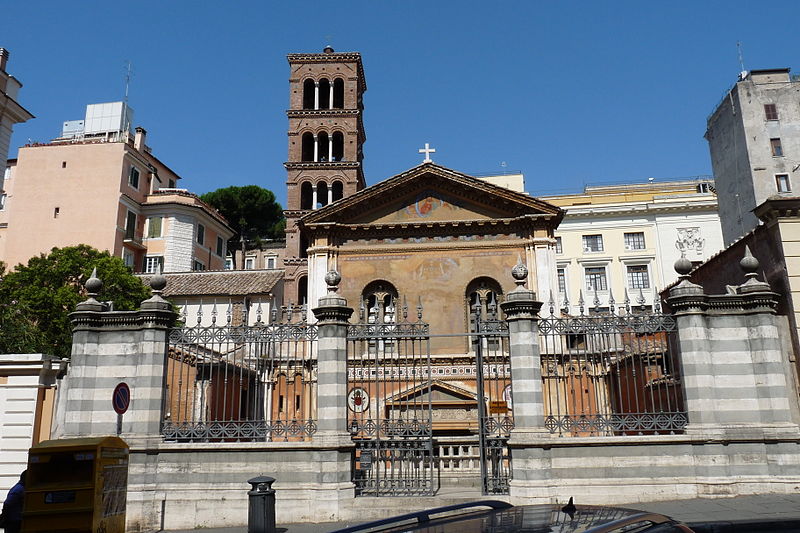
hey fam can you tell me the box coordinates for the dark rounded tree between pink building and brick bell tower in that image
[200,185,286,266]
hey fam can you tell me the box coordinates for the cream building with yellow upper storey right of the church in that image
[540,180,723,314]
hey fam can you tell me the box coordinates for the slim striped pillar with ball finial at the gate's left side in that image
[313,271,353,441]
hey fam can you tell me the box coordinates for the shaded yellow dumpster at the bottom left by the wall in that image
[22,437,128,533]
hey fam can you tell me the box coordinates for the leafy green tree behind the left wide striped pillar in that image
[0,244,150,357]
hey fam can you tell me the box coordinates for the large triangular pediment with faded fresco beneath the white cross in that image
[301,163,563,225]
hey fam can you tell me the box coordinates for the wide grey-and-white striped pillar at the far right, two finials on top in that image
[668,250,797,437]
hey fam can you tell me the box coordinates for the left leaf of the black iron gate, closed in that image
[347,301,437,496]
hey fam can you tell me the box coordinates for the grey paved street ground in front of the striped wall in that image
[170,494,800,533]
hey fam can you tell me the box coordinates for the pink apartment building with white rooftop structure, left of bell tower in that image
[0,102,234,272]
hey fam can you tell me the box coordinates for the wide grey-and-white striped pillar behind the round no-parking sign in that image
[53,273,175,442]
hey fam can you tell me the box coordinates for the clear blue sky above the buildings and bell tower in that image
[0,0,800,206]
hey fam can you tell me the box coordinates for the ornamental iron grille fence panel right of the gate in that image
[539,297,688,437]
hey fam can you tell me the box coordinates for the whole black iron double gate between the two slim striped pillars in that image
[347,295,514,496]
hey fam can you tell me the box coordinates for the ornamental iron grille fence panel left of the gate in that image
[161,304,317,442]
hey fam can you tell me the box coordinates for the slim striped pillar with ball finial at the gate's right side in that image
[500,263,546,433]
